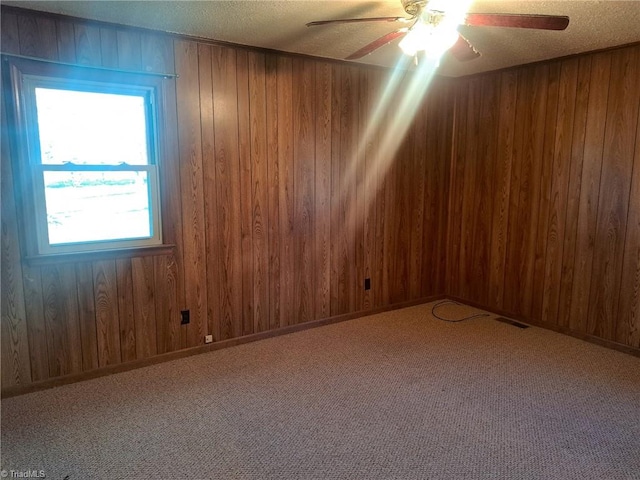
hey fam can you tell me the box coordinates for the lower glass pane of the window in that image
[44,171,152,245]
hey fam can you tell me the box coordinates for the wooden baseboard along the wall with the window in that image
[2,295,446,398]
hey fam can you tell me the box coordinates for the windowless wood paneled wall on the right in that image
[447,46,640,349]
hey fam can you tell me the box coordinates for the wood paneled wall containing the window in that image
[1,8,453,389]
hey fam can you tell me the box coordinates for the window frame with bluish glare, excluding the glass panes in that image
[5,55,168,258]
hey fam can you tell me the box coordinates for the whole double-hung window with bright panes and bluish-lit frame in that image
[5,59,169,256]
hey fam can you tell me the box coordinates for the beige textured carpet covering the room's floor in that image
[2,304,640,480]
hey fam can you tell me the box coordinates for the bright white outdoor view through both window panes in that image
[35,88,152,245]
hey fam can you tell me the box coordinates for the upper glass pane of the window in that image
[35,88,149,165]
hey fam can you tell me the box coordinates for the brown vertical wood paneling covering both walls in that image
[20,6,640,394]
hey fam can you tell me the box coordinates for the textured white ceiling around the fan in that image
[2,0,640,76]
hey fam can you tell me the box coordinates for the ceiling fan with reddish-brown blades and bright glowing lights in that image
[307,0,569,61]
